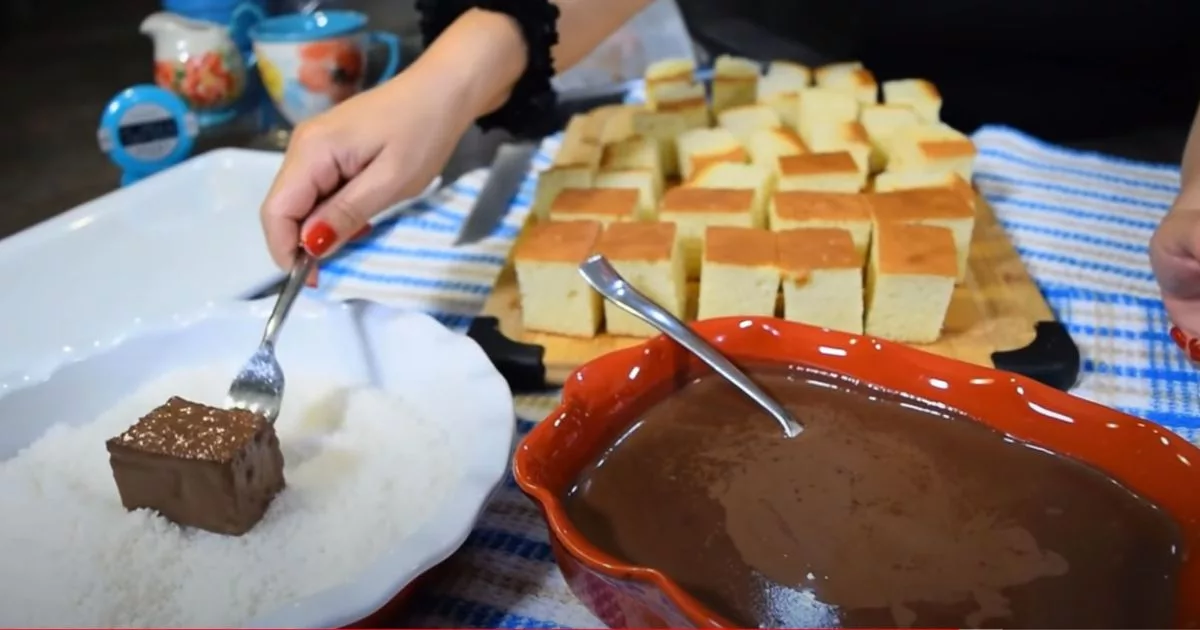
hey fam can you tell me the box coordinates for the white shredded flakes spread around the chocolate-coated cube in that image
[0,366,458,628]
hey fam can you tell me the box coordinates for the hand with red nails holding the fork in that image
[260,66,475,269]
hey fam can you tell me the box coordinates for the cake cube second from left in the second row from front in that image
[659,186,755,278]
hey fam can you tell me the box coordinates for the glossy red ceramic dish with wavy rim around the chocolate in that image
[514,318,1200,628]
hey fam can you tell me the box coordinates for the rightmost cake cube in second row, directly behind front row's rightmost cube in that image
[868,188,974,282]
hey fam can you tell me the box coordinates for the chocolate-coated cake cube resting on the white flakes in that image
[107,397,283,535]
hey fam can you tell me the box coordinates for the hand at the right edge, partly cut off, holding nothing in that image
[1150,204,1200,361]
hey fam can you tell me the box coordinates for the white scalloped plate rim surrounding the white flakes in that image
[0,296,516,628]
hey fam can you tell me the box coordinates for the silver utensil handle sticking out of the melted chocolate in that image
[580,254,804,438]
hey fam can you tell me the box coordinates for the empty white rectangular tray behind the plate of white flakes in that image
[0,149,283,378]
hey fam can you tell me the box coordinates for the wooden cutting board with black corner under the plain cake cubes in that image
[482,198,1079,389]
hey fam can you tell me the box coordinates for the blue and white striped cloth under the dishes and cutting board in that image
[319,127,1200,628]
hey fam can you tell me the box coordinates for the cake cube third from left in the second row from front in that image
[768,191,872,259]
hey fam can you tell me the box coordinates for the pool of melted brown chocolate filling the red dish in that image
[566,367,1183,628]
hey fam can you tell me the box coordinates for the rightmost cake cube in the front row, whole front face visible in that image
[864,218,955,343]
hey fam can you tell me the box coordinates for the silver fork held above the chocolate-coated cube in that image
[226,248,316,422]
